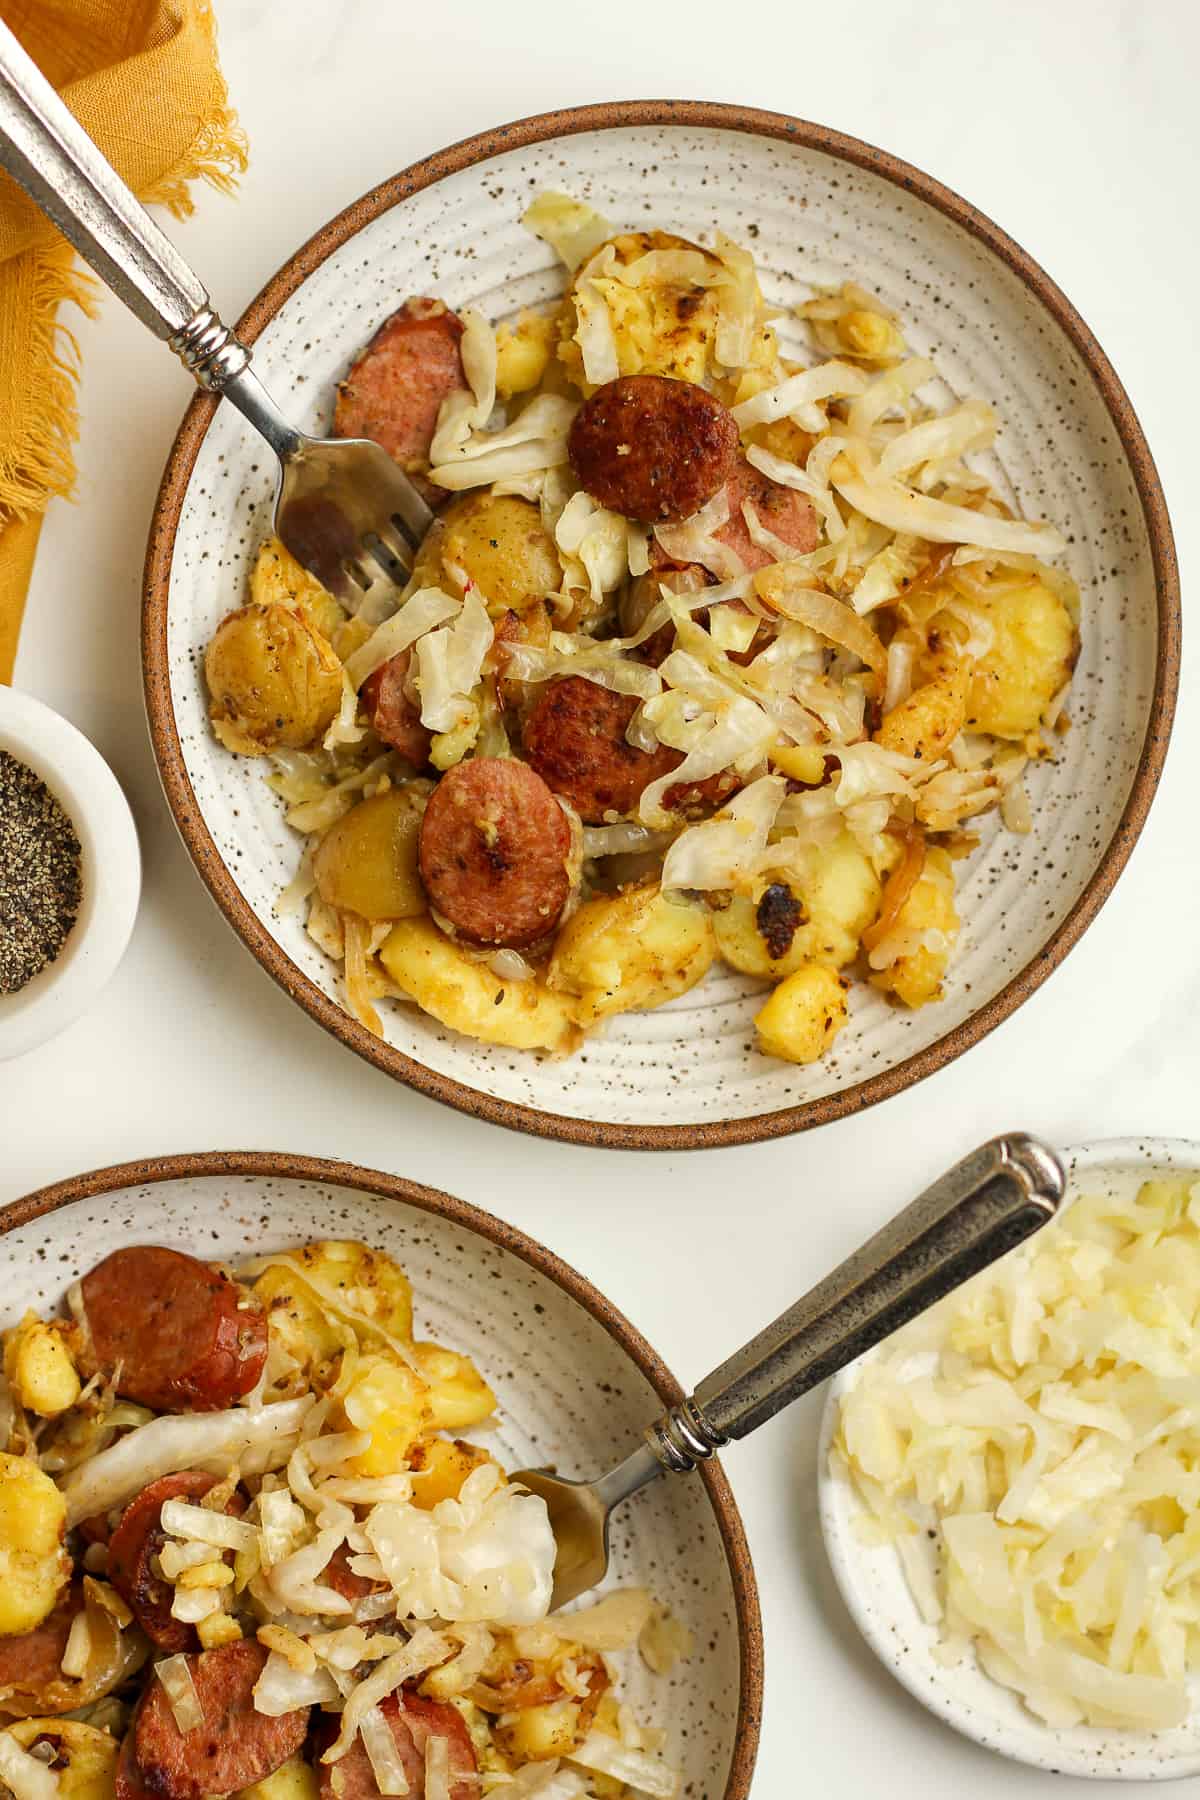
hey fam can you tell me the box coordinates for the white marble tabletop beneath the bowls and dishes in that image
[0,0,1200,1800]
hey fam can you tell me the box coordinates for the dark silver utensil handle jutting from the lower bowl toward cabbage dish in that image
[646,1132,1065,1471]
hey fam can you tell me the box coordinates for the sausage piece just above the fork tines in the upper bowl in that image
[333,299,466,470]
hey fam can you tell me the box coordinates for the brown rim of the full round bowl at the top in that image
[142,99,1182,1150]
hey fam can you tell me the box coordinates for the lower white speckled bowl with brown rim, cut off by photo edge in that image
[0,1152,763,1800]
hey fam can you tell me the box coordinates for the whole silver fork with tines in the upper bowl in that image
[0,23,434,598]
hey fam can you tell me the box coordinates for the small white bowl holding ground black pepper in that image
[0,688,142,1062]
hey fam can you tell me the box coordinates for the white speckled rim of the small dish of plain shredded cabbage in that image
[817,1136,1200,1782]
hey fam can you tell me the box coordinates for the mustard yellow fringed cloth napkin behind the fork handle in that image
[0,0,246,682]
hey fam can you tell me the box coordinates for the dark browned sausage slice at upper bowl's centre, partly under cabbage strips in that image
[524,675,741,824]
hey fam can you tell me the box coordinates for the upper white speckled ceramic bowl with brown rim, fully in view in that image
[144,101,1178,1148]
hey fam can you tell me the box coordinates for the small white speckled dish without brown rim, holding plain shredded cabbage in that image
[817,1138,1200,1782]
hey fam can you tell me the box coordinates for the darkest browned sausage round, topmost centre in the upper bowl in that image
[567,374,738,524]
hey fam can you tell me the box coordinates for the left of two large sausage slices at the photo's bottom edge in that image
[131,1638,309,1800]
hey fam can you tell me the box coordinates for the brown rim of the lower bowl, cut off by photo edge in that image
[0,1150,763,1800]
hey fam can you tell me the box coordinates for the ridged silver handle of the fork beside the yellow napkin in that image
[0,23,250,389]
